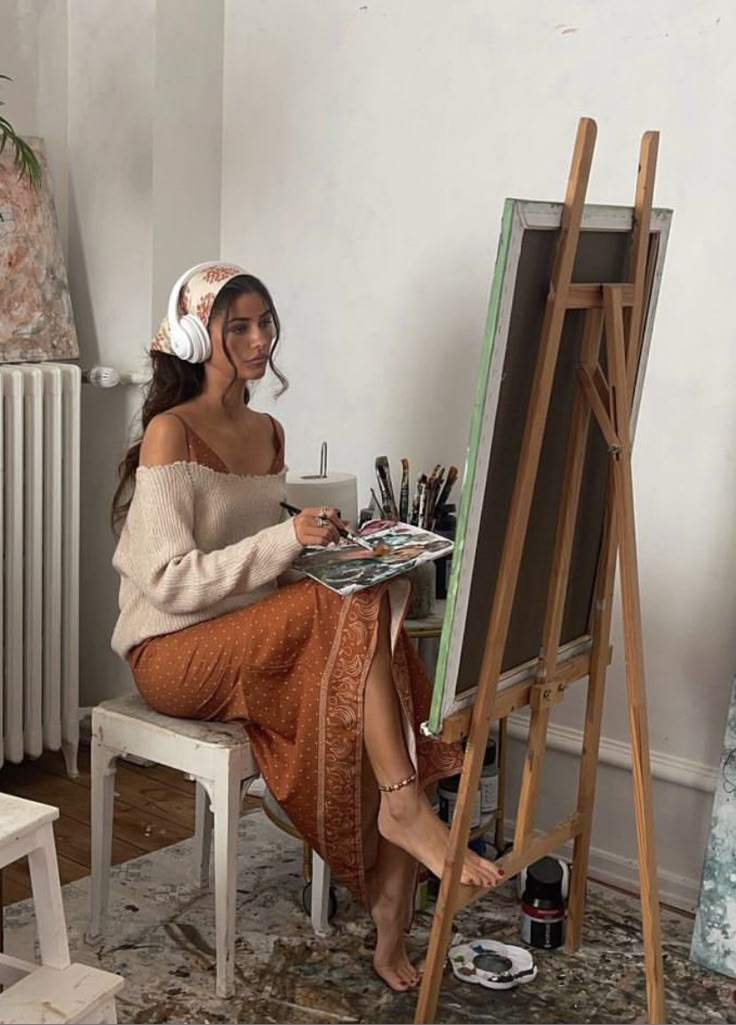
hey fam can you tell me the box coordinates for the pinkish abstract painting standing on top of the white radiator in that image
[0,138,79,363]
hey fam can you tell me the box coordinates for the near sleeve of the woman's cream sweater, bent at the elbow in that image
[114,463,301,613]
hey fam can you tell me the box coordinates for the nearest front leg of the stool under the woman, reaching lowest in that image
[212,759,240,997]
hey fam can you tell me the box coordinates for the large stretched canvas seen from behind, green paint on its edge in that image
[426,199,671,734]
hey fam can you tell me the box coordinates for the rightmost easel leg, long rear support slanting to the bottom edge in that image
[604,285,665,1023]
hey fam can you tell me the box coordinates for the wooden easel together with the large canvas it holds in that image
[416,118,671,1022]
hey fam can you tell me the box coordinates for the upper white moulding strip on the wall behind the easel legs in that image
[508,712,719,793]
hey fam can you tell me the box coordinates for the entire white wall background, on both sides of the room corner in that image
[0,0,736,899]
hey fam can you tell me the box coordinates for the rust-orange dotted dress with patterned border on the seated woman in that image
[128,426,461,902]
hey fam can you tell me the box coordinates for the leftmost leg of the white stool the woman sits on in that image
[89,736,117,937]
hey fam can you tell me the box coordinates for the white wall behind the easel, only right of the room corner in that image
[221,0,736,898]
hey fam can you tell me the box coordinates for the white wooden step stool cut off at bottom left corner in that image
[0,793,123,1025]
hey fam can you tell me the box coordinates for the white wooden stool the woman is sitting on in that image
[90,694,329,996]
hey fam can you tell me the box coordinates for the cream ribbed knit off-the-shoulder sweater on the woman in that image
[112,462,301,657]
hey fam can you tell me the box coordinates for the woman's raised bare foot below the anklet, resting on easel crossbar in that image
[378,786,503,887]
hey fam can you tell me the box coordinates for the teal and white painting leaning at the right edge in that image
[690,681,736,978]
